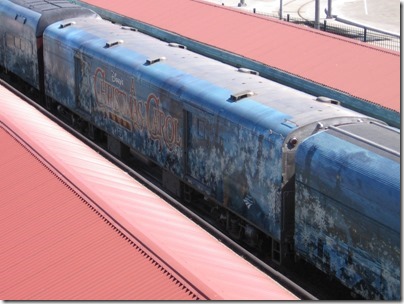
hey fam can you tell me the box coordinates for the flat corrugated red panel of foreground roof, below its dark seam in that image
[0,128,202,300]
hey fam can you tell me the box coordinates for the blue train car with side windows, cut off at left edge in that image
[0,0,97,90]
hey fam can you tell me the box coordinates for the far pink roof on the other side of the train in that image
[82,0,400,112]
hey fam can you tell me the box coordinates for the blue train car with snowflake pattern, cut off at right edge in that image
[295,123,401,300]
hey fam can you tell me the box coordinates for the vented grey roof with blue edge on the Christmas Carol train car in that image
[44,19,376,133]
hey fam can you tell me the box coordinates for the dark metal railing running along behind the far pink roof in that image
[253,9,400,52]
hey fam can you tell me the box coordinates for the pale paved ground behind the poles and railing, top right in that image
[205,0,401,34]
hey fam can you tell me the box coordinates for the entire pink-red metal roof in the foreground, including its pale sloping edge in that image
[0,87,297,300]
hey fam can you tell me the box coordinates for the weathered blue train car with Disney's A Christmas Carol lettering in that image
[44,19,372,261]
